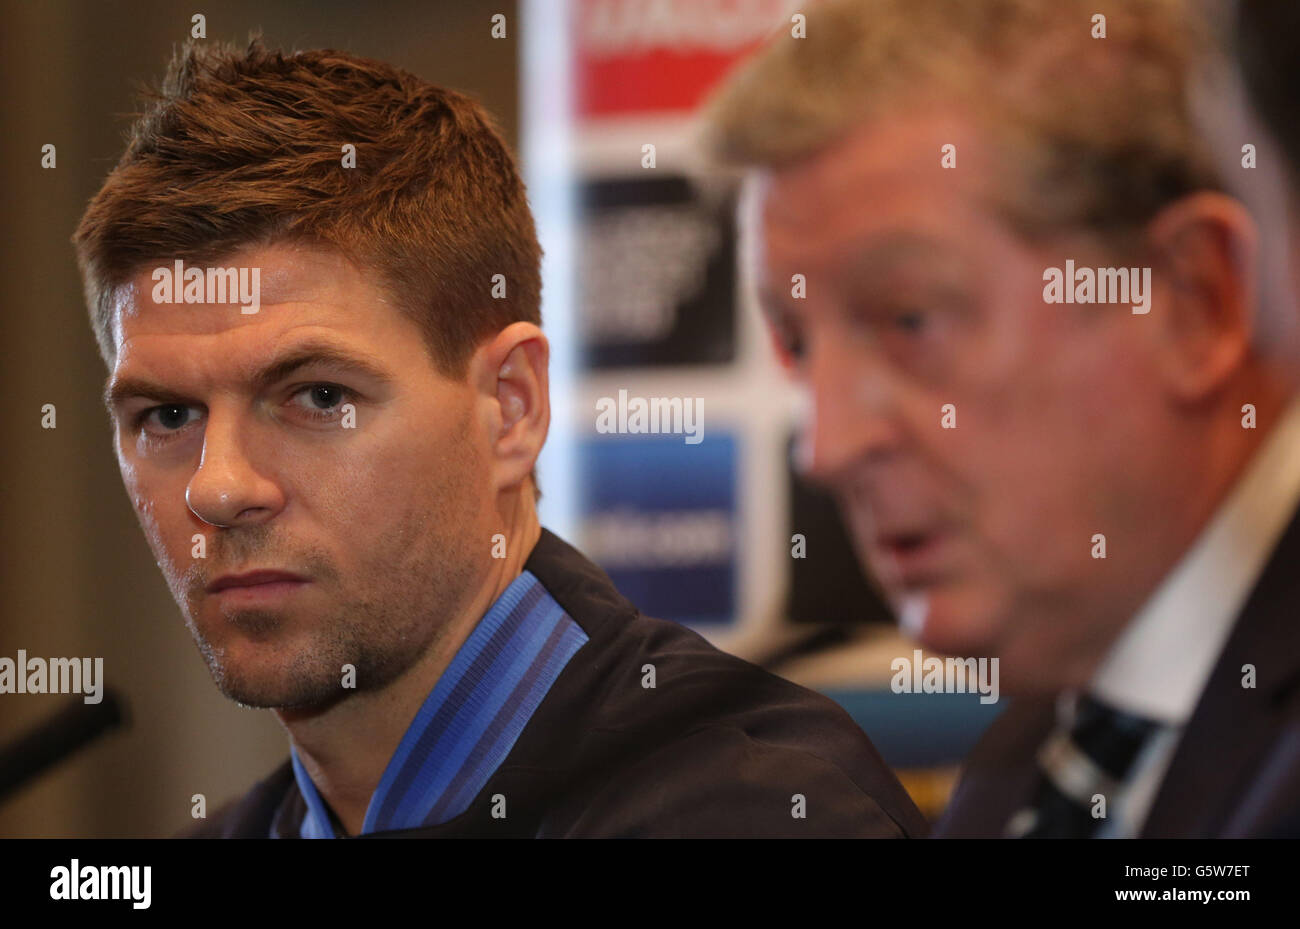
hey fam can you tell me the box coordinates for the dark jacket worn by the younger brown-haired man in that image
[189,530,927,838]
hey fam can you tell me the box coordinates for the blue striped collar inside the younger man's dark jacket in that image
[290,570,586,838]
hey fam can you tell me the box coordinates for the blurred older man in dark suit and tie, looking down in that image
[707,0,1300,837]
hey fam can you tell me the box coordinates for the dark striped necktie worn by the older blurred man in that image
[1006,695,1157,838]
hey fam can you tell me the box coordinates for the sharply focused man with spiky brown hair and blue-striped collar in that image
[75,42,926,838]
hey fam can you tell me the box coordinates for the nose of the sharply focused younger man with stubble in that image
[185,411,285,526]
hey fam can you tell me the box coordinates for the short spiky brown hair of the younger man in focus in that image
[73,38,541,377]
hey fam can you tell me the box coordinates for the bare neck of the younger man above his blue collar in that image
[274,482,542,835]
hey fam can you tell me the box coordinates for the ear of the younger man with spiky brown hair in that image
[469,322,551,490]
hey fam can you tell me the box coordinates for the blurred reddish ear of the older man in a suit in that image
[1134,192,1260,403]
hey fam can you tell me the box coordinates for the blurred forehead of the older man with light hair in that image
[750,108,1000,270]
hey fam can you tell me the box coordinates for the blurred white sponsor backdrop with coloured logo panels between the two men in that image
[533,0,998,815]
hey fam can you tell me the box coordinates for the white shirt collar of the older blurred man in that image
[1089,396,1300,726]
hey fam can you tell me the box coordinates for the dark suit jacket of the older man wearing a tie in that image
[935,504,1300,838]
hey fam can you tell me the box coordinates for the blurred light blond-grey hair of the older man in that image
[703,0,1222,238]
